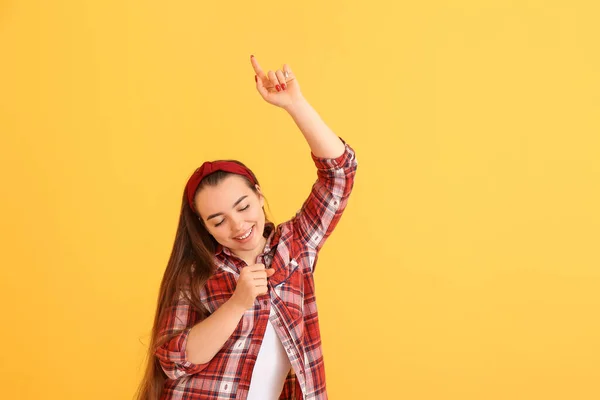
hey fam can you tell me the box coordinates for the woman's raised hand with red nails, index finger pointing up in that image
[250,56,303,109]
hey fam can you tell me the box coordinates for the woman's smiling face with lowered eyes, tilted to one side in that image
[194,175,265,255]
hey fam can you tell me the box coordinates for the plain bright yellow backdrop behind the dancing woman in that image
[0,0,600,400]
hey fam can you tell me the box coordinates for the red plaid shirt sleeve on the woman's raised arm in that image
[292,138,357,252]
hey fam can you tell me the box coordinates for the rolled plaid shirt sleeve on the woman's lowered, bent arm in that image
[155,295,208,379]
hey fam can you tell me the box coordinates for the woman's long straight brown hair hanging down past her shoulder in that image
[135,160,269,400]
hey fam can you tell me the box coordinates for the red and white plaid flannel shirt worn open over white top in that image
[155,138,357,400]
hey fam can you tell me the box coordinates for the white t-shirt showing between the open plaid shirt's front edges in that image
[247,307,292,400]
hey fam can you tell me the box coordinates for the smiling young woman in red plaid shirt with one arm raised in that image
[137,56,357,400]
